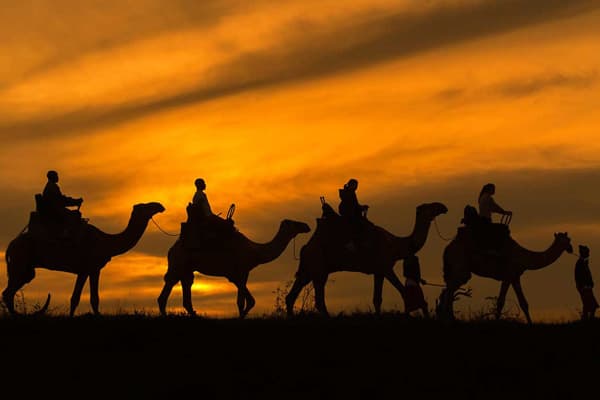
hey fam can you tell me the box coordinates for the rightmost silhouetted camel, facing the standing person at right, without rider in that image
[437,212,573,324]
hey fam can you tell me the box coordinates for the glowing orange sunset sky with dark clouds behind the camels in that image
[0,0,600,320]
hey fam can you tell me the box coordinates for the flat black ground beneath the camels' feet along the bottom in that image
[0,314,600,399]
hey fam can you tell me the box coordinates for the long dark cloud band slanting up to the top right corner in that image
[0,0,600,140]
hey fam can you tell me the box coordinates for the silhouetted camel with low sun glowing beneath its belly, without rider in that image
[157,219,310,318]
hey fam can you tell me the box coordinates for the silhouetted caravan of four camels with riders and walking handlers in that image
[2,171,598,323]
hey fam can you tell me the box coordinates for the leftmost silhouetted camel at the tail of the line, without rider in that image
[2,203,165,317]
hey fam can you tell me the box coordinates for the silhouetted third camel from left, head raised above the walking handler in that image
[286,200,448,316]
